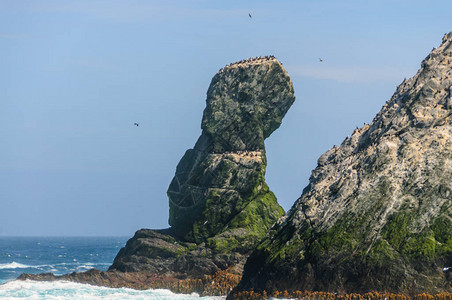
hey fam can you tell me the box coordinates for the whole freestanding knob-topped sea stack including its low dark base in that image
[110,57,295,278]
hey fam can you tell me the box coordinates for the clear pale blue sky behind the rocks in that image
[0,0,452,236]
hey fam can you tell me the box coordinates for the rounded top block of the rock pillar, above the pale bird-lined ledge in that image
[202,58,295,153]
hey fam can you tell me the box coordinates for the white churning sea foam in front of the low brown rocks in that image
[0,280,225,300]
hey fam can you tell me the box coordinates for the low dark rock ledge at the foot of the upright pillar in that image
[109,229,245,279]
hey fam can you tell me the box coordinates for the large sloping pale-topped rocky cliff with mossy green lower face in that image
[238,33,452,293]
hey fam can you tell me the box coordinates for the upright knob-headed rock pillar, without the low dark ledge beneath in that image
[168,57,295,243]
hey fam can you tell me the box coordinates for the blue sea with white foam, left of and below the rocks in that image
[0,237,224,300]
